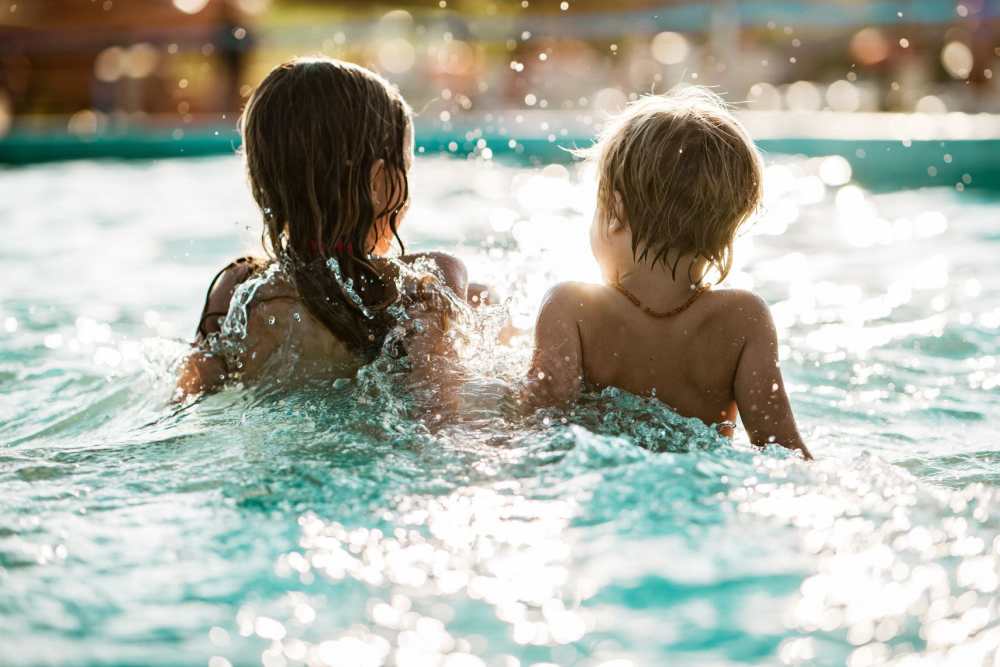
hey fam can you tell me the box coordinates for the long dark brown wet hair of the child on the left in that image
[240,58,412,355]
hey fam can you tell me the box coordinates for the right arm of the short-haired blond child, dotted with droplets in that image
[733,296,812,459]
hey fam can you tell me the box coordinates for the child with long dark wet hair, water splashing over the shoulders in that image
[178,58,468,396]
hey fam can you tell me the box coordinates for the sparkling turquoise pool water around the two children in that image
[0,158,1000,667]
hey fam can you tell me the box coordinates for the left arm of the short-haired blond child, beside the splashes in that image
[524,283,583,406]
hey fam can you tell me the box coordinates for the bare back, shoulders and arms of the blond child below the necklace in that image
[532,283,804,456]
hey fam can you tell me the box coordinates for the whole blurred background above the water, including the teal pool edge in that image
[0,0,1000,187]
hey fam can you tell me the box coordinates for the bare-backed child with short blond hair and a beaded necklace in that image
[527,87,810,458]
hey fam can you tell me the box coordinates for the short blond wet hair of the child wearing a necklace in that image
[577,86,763,282]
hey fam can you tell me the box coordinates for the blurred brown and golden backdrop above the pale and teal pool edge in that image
[0,0,1000,138]
